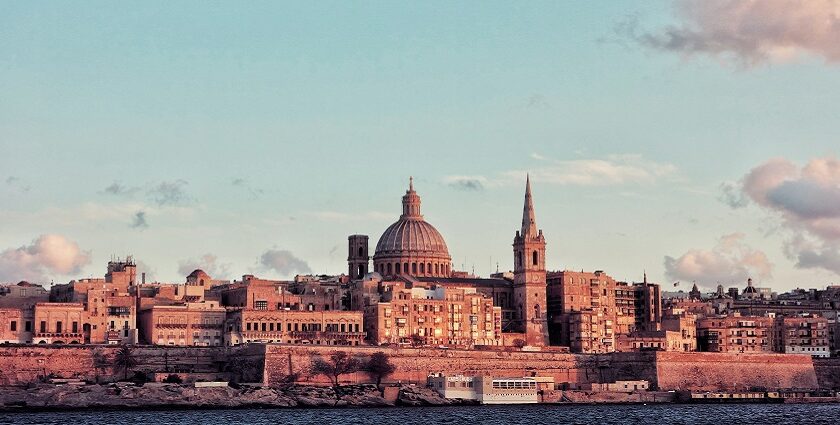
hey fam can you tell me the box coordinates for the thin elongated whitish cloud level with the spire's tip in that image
[505,154,677,186]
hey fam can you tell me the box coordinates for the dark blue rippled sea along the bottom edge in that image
[0,404,840,425]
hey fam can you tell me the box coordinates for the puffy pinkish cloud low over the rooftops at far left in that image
[0,234,90,282]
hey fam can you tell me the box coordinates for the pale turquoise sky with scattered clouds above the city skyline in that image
[0,0,840,291]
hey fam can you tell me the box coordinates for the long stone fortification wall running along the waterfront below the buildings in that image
[0,344,840,391]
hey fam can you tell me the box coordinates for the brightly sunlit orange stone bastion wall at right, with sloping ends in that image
[656,352,819,391]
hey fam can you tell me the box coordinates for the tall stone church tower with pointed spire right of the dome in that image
[513,177,548,346]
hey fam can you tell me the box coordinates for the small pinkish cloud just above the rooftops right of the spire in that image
[664,233,773,287]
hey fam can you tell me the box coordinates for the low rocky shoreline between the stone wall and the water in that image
[0,383,475,412]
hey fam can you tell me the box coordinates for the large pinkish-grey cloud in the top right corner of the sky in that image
[628,0,840,66]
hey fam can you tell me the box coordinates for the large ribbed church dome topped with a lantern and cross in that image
[373,179,452,277]
